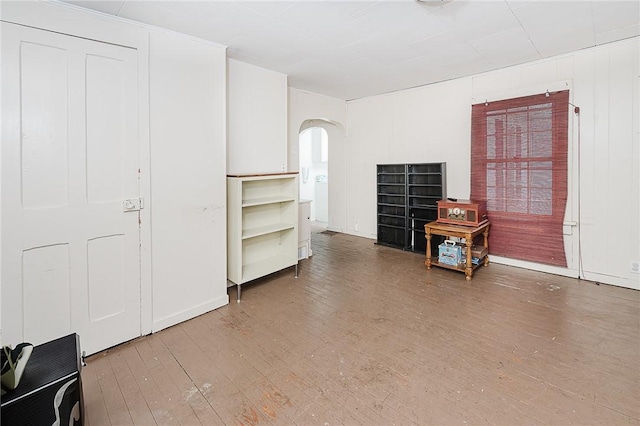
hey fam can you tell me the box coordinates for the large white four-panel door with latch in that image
[2,23,141,354]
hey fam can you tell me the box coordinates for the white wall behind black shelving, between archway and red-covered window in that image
[346,79,471,239]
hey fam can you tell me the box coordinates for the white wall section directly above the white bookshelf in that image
[227,59,288,174]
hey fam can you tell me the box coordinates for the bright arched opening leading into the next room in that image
[298,127,329,229]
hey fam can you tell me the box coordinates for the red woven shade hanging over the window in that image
[471,91,569,266]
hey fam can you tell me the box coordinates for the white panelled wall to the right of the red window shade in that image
[573,37,640,289]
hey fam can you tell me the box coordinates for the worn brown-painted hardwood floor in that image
[82,233,640,426]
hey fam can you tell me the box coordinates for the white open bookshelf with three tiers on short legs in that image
[227,173,298,302]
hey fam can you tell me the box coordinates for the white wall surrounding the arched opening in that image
[288,88,347,232]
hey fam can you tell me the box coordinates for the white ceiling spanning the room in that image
[62,0,640,100]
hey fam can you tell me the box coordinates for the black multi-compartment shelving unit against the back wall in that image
[377,163,446,253]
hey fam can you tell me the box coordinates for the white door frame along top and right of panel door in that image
[1,2,153,336]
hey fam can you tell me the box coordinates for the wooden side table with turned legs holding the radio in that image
[424,221,491,281]
